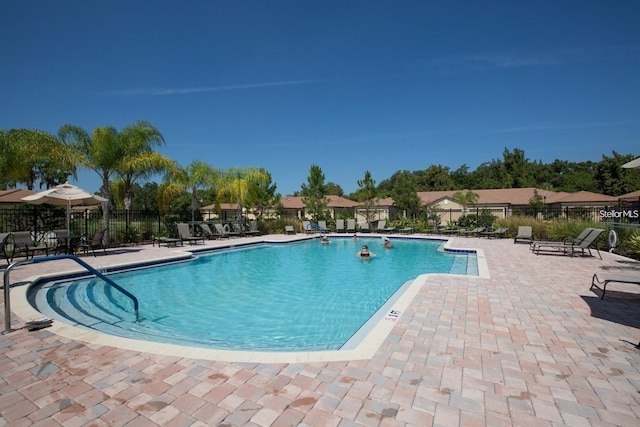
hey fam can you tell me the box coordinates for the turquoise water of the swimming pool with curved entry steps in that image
[29,238,477,351]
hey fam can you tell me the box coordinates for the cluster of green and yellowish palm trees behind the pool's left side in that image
[0,121,276,244]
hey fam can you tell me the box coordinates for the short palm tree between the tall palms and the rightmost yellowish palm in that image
[158,160,219,223]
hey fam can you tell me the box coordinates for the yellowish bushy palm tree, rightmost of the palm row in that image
[216,168,271,224]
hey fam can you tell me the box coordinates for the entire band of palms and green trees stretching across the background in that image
[0,121,640,224]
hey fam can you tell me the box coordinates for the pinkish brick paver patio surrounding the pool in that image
[0,238,640,426]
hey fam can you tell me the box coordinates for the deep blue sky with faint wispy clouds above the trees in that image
[0,0,640,195]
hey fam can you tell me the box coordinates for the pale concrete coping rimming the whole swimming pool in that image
[11,233,490,363]
